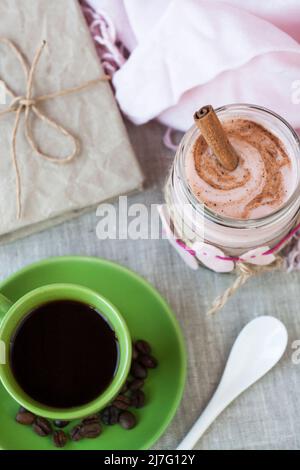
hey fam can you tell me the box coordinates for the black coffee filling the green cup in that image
[10,300,118,408]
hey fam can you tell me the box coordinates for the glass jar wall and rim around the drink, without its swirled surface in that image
[165,104,300,257]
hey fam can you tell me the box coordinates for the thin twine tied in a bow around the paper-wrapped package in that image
[0,37,110,219]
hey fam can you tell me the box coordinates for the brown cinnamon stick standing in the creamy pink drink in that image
[194,105,239,171]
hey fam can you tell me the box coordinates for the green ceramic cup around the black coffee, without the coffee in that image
[0,284,131,420]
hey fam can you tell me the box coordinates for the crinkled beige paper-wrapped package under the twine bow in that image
[0,0,143,241]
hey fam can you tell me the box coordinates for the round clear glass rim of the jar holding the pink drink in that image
[178,103,300,229]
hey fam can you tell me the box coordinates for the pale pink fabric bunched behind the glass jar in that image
[89,0,300,130]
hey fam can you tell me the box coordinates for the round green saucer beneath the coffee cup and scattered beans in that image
[0,257,186,450]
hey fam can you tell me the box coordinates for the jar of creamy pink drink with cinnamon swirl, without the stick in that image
[165,104,300,256]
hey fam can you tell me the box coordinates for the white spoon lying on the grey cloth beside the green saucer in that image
[177,316,288,450]
